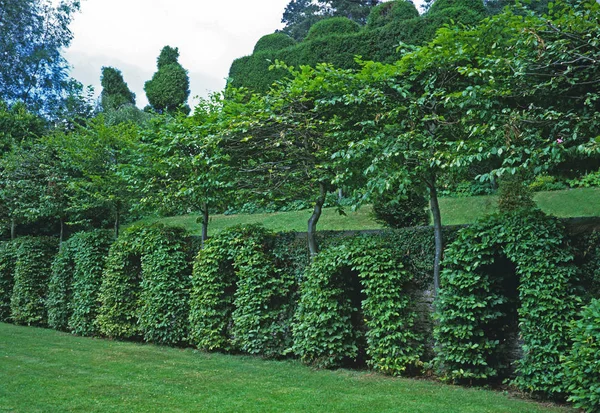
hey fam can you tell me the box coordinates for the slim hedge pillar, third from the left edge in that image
[46,241,75,331]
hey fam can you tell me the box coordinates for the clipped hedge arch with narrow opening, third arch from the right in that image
[190,226,296,357]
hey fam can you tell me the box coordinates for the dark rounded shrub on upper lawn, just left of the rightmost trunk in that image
[373,189,429,228]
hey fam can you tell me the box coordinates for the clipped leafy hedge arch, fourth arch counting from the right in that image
[97,225,190,345]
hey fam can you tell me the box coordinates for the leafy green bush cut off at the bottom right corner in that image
[563,299,600,412]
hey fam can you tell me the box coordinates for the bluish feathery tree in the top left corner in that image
[0,0,79,116]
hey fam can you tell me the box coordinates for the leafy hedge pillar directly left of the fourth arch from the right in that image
[68,230,114,336]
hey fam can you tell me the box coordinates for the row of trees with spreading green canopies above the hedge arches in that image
[0,0,600,296]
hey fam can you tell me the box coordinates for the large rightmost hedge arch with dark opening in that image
[435,211,578,397]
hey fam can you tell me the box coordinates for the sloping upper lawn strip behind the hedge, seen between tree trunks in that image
[138,188,600,234]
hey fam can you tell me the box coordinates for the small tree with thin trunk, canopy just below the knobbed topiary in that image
[126,95,233,245]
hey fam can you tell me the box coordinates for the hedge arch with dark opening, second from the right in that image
[294,237,425,374]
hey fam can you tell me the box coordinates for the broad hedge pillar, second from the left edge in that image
[10,237,58,326]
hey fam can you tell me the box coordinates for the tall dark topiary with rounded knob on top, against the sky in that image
[144,46,190,113]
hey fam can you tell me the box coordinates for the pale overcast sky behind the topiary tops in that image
[65,0,422,107]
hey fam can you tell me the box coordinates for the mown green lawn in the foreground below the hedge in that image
[0,323,574,413]
